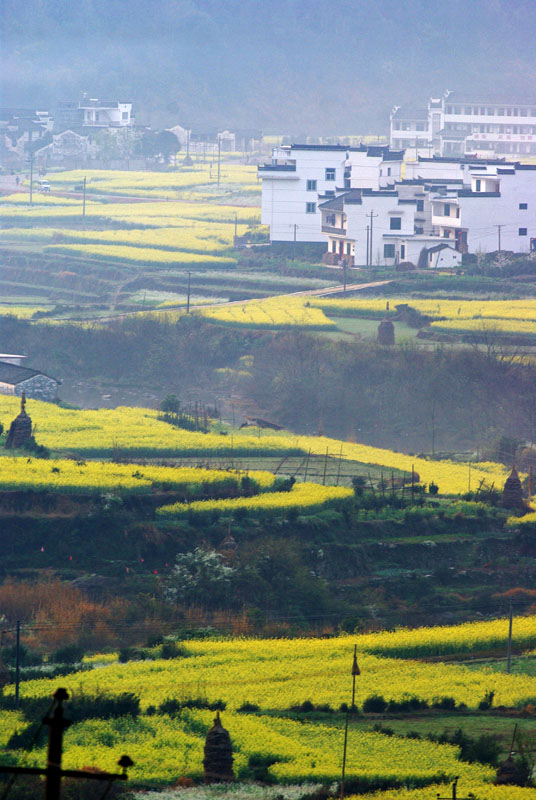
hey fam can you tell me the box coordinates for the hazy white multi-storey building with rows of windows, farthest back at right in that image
[390,91,536,158]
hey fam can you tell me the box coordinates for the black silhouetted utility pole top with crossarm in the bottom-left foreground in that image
[0,689,133,800]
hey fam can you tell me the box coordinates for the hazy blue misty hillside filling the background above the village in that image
[0,0,536,135]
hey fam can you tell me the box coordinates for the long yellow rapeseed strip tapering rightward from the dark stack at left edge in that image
[0,395,508,494]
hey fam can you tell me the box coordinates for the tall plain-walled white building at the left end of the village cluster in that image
[259,144,404,242]
